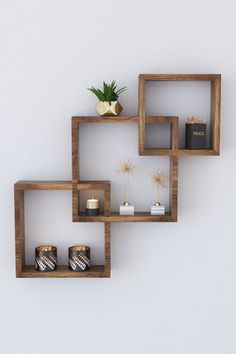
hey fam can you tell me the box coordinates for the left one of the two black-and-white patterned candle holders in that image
[35,246,57,272]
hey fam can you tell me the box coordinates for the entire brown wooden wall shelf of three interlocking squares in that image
[14,74,221,278]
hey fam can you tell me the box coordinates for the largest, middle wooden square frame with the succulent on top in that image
[71,116,178,222]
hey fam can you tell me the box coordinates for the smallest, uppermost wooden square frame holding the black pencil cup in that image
[139,74,221,156]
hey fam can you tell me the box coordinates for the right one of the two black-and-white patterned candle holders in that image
[68,246,91,272]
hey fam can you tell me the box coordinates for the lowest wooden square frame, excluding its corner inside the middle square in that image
[14,181,111,278]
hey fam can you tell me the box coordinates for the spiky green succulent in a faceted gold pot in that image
[88,80,126,116]
